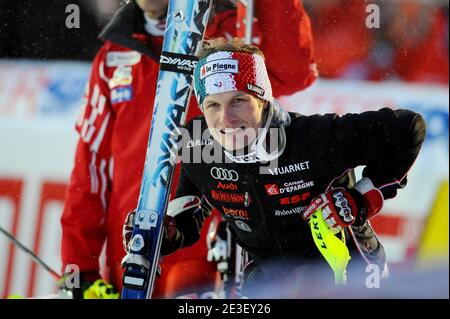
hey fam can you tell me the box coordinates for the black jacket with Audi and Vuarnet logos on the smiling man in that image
[171,108,425,268]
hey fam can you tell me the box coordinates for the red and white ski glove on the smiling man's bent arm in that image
[303,177,383,234]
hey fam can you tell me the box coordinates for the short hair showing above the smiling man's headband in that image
[197,38,264,59]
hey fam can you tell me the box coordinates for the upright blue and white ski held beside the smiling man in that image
[121,0,212,299]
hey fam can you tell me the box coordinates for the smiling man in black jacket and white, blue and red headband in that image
[125,39,425,297]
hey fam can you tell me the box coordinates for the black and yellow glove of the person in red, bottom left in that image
[58,272,119,299]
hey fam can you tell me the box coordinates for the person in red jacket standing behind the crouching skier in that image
[61,0,316,298]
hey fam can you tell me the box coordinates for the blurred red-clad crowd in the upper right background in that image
[304,0,449,84]
